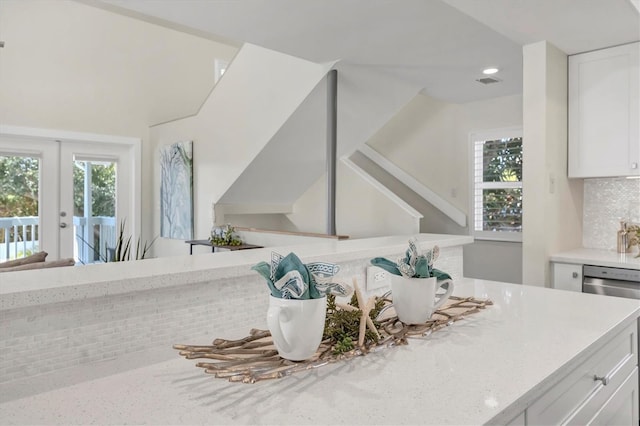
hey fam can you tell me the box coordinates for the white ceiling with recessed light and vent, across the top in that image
[92,0,640,102]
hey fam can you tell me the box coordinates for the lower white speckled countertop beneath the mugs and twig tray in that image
[0,279,640,425]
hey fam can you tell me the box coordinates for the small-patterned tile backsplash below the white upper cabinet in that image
[582,178,640,250]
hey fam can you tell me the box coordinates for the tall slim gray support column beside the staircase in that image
[327,70,338,235]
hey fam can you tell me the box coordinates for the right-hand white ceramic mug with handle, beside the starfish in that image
[391,274,453,324]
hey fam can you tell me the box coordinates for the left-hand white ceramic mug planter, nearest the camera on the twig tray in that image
[267,296,327,361]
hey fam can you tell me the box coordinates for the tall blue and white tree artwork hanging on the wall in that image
[160,141,193,240]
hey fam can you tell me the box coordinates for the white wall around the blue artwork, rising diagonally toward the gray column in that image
[150,44,332,256]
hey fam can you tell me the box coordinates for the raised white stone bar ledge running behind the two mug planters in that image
[0,234,473,312]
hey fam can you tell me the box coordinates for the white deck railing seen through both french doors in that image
[0,216,116,264]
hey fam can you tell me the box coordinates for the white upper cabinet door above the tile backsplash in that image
[569,42,640,178]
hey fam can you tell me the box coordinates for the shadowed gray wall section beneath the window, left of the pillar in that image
[463,240,522,284]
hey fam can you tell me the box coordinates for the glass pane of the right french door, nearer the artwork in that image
[73,160,116,264]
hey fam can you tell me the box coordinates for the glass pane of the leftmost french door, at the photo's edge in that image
[0,155,40,262]
